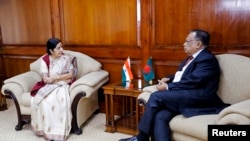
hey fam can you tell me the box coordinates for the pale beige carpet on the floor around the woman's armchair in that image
[0,100,131,141]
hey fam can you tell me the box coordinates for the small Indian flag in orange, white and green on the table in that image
[122,57,134,82]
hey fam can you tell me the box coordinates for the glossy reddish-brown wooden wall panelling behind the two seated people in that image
[0,0,250,83]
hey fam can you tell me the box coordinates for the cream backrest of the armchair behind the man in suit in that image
[216,54,250,104]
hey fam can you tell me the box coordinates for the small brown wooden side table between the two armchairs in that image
[102,79,151,135]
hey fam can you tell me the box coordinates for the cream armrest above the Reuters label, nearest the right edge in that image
[217,99,250,124]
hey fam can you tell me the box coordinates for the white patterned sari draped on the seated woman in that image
[31,55,77,140]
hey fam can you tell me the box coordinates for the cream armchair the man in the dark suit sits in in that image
[138,54,250,141]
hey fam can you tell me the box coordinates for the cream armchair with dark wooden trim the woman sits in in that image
[1,50,109,135]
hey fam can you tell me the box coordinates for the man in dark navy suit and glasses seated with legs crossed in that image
[120,30,227,141]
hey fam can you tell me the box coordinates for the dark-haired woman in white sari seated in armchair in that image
[31,38,77,141]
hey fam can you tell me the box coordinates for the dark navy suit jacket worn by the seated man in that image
[168,48,228,117]
